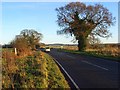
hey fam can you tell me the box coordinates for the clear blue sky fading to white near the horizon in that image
[0,2,118,44]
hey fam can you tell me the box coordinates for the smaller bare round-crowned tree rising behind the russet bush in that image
[20,29,43,50]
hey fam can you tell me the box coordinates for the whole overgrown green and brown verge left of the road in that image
[2,50,69,89]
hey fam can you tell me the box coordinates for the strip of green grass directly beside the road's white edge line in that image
[45,54,69,88]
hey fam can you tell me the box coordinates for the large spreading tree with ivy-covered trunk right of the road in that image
[56,2,115,51]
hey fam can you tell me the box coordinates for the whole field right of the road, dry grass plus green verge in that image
[54,45,120,59]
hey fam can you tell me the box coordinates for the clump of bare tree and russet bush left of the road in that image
[11,29,43,55]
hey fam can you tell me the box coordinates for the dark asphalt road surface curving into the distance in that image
[49,49,120,89]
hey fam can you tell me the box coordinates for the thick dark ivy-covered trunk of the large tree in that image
[78,37,86,51]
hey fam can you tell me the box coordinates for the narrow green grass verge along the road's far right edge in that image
[58,49,120,61]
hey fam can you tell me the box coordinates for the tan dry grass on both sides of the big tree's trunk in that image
[59,45,120,57]
